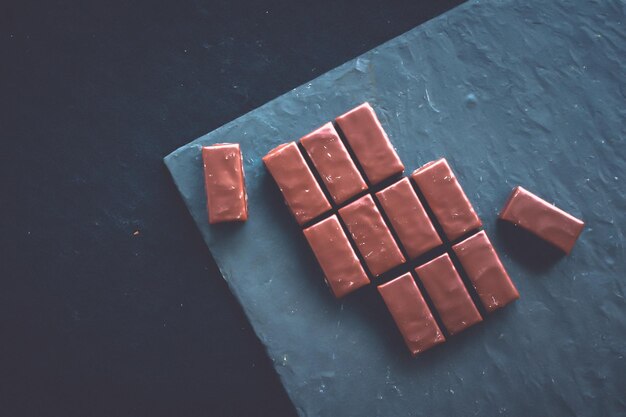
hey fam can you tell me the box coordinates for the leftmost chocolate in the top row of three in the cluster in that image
[263,142,331,225]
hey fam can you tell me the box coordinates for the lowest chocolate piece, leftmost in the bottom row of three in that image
[378,272,446,355]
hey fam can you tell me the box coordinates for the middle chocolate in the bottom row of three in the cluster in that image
[415,253,483,334]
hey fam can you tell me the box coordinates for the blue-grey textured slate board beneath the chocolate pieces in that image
[165,0,626,417]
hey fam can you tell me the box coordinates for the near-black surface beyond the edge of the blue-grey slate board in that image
[0,0,461,416]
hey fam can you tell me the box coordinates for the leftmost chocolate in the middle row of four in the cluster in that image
[304,215,370,298]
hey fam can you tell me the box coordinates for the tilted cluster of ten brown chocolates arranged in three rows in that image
[263,103,519,355]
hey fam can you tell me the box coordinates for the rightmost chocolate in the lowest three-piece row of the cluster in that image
[452,230,519,312]
